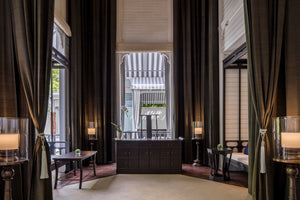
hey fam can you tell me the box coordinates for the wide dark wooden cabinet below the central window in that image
[115,139,182,174]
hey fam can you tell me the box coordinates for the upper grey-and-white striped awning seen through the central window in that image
[125,52,165,78]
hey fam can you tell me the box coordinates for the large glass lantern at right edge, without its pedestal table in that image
[273,116,300,163]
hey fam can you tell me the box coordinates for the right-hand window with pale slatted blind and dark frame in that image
[224,65,248,152]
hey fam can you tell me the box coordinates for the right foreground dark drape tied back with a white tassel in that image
[244,0,286,199]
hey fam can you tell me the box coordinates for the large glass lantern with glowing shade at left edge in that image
[0,117,29,163]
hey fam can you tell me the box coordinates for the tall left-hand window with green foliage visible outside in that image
[45,25,69,155]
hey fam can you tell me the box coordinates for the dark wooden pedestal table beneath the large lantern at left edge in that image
[0,159,28,200]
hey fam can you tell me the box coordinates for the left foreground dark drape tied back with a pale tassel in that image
[11,0,54,200]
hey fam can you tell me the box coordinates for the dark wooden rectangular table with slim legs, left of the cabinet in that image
[53,151,97,189]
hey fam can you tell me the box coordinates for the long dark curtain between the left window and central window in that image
[70,0,117,163]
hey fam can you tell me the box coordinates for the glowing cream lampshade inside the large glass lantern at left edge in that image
[0,133,20,150]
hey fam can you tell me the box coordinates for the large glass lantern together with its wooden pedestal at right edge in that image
[273,116,300,200]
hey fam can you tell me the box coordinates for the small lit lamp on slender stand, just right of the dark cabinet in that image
[192,121,203,166]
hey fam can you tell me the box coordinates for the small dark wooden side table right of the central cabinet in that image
[207,148,232,180]
